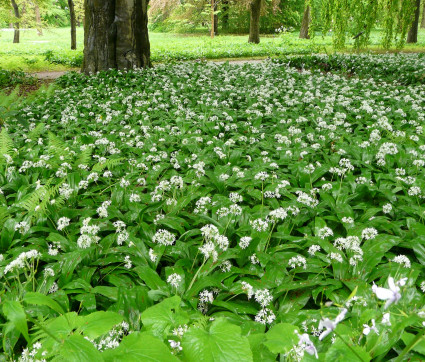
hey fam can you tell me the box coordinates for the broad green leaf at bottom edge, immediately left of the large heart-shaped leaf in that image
[102,333,178,362]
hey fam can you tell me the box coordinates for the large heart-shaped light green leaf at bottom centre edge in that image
[182,318,253,362]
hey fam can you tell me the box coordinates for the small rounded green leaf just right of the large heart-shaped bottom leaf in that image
[264,323,299,353]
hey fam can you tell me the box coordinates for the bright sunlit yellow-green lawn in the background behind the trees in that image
[0,28,425,72]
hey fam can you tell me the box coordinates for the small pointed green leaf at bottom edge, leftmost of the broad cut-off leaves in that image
[59,334,103,362]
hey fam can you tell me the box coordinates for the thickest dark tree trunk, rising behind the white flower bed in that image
[83,0,151,74]
